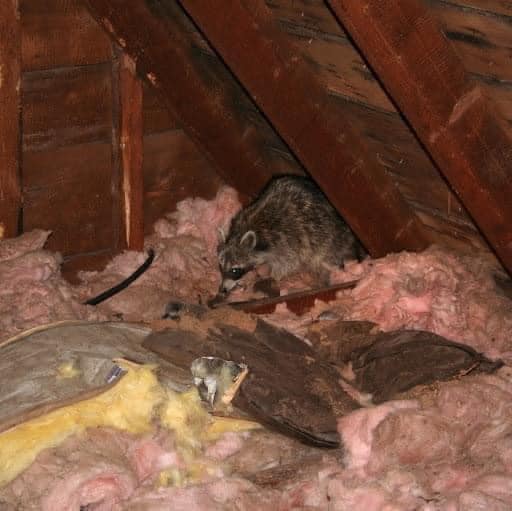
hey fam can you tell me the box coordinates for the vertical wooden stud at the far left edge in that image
[0,0,21,239]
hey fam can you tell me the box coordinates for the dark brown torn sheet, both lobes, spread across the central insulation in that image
[143,309,501,447]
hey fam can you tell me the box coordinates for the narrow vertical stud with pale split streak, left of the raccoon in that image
[119,54,144,250]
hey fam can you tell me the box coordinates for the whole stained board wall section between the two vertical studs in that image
[20,0,118,264]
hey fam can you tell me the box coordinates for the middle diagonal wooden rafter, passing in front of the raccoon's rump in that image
[176,0,428,256]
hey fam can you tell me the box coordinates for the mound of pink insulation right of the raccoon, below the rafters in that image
[268,247,512,362]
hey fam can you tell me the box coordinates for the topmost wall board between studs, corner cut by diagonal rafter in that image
[20,0,111,71]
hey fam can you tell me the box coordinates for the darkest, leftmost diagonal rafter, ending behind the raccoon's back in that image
[84,0,278,195]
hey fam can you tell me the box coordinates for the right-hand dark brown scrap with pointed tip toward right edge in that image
[308,320,503,404]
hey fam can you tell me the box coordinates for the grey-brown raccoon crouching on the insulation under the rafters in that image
[218,175,365,295]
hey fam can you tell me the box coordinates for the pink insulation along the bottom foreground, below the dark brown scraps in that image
[5,367,512,511]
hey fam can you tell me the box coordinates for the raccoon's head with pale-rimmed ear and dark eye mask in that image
[218,231,263,294]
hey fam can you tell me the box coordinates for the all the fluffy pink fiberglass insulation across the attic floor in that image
[0,188,512,511]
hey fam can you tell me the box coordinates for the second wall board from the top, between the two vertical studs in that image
[22,63,112,151]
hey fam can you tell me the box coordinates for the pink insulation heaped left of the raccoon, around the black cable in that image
[0,187,240,339]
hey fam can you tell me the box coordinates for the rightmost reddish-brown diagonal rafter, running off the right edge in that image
[328,0,512,271]
